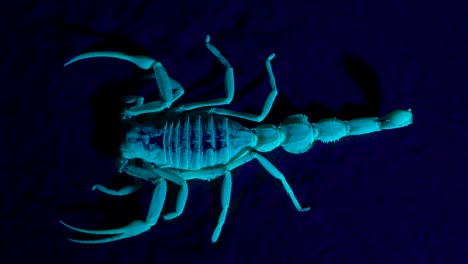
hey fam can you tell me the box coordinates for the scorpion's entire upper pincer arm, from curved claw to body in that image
[64,51,184,118]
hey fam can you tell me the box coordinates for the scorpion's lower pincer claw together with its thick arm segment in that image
[60,179,167,244]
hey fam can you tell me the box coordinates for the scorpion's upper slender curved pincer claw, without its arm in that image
[63,51,156,70]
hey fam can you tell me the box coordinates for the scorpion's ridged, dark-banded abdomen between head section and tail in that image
[162,114,256,170]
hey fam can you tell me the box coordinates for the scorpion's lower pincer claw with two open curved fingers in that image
[59,220,150,244]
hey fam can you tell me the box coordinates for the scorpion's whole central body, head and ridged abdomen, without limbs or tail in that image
[120,113,257,170]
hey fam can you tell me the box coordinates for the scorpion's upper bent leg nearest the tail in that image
[210,53,278,122]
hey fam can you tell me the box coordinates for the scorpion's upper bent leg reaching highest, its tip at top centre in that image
[168,35,234,112]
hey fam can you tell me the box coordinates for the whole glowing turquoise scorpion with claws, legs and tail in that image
[59,35,413,243]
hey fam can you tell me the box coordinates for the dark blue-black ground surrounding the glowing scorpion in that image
[0,0,468,264]
